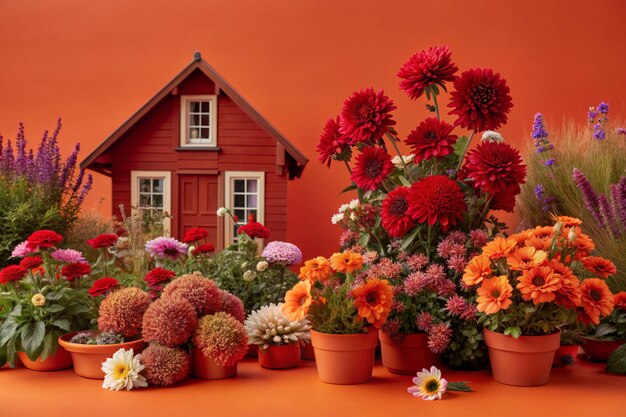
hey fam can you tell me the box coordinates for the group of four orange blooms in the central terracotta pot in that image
[282,251,393,328]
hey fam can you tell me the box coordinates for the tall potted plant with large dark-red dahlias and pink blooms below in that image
[317,46,525,374]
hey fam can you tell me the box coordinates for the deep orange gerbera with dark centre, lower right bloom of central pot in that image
[351,278,393,328]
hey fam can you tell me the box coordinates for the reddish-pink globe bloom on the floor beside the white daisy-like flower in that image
[141,343,191,387]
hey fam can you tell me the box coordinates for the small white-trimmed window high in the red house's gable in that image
[180,95,217,147]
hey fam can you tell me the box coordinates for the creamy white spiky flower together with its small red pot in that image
[244,304,311,369]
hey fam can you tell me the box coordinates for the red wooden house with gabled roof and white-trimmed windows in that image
[81,52,308,248]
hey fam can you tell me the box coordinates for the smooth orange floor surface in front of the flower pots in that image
[0,358,626,417]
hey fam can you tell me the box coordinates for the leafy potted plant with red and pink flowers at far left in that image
[0,230,97,371]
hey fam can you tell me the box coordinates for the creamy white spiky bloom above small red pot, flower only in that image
[244,303,311,349]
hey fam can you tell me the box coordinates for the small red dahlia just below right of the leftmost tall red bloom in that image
[350,146,393,190]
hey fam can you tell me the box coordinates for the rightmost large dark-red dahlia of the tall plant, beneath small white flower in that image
[461,142,526,206]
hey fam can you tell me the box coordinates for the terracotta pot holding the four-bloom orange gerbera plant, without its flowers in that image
[311,327,378,385]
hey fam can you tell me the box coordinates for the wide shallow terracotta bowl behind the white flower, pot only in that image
[59,332,146,379]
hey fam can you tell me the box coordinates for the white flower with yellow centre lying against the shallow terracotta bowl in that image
[102,348,148,391]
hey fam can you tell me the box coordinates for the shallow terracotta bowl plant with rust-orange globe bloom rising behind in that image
[59,287,150,379]
